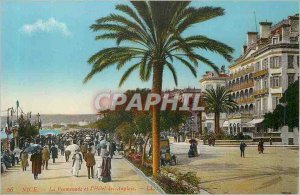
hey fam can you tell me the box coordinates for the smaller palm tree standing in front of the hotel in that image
[204,87,238,134]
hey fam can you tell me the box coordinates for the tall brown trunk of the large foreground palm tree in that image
[152,62,163,177]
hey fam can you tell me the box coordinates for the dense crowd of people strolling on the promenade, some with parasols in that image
[1,129,123,182]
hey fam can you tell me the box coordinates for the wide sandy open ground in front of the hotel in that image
[171,143,299,194]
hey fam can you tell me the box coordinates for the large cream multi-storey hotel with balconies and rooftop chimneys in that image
[228,14,299,135]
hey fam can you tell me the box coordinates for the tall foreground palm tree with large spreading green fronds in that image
[84,1,233,176]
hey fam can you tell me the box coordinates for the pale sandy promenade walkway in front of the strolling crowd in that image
[1,156,157,194]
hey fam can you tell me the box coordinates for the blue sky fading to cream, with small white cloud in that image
[0,0,299,115]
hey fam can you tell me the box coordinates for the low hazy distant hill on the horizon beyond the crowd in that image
[1,114,97,127]
